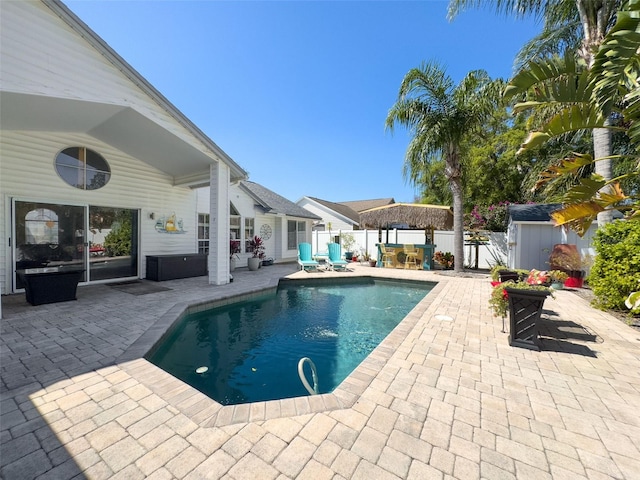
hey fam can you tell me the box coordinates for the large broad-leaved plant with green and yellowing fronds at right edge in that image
[507,0,640,235]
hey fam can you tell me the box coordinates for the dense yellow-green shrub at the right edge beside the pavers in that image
[588,221,640,310]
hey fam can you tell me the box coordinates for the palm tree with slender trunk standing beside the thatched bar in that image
[386,62,502,272]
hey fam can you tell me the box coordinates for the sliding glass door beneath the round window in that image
[12,200,139,289]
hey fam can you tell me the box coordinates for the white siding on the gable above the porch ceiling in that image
[0,1,218,163]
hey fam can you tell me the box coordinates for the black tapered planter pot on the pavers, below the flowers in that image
[505,287,549,350]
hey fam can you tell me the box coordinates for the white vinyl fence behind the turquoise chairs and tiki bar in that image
[311,229,507,269]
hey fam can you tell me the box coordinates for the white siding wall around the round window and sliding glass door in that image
[0,131,197,293]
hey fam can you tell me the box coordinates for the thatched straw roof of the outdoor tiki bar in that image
[360,203,453,230]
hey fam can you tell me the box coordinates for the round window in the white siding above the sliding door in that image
[56,147,111,190]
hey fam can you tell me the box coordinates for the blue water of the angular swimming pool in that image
[147,280,433,405]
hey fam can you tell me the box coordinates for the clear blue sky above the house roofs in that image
[65,0,538,202]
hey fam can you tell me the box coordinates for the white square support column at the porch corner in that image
[208,162,230,285]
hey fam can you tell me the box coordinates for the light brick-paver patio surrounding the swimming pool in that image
[0,265,640,480]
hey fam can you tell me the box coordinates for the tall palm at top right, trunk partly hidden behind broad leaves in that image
[449,0,623,224]
